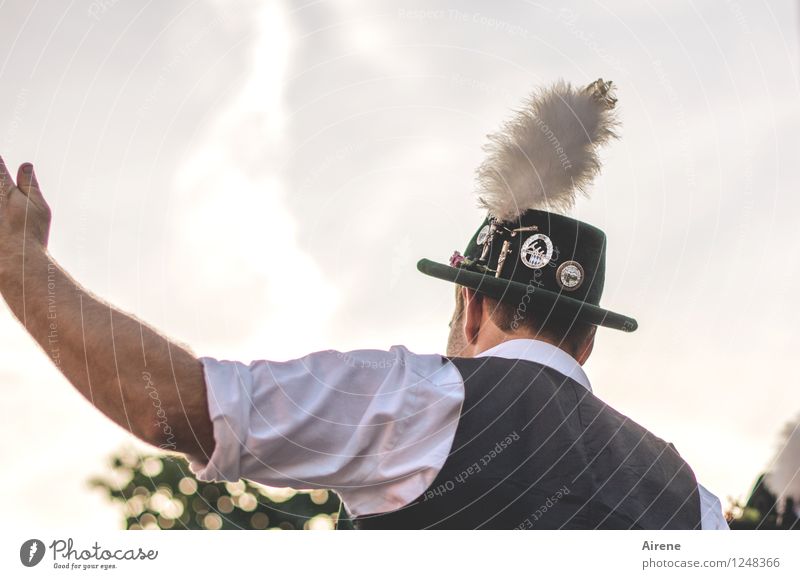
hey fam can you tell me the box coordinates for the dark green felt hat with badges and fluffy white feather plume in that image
[417,79,638,332]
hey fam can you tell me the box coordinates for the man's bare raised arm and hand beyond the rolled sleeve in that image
[0,158,214,458]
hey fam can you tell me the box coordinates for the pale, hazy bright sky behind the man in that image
[0,0,800,529]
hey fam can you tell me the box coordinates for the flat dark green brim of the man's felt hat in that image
[417,259,639,332]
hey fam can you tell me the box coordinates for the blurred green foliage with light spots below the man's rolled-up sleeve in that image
[91,449,339,529]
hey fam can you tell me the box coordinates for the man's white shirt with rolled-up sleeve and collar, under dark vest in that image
[192,339,728,529]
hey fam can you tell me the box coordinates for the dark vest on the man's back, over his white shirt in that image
[354,357,700,529]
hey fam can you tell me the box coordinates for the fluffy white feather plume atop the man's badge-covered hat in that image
[477,79,618,221]
